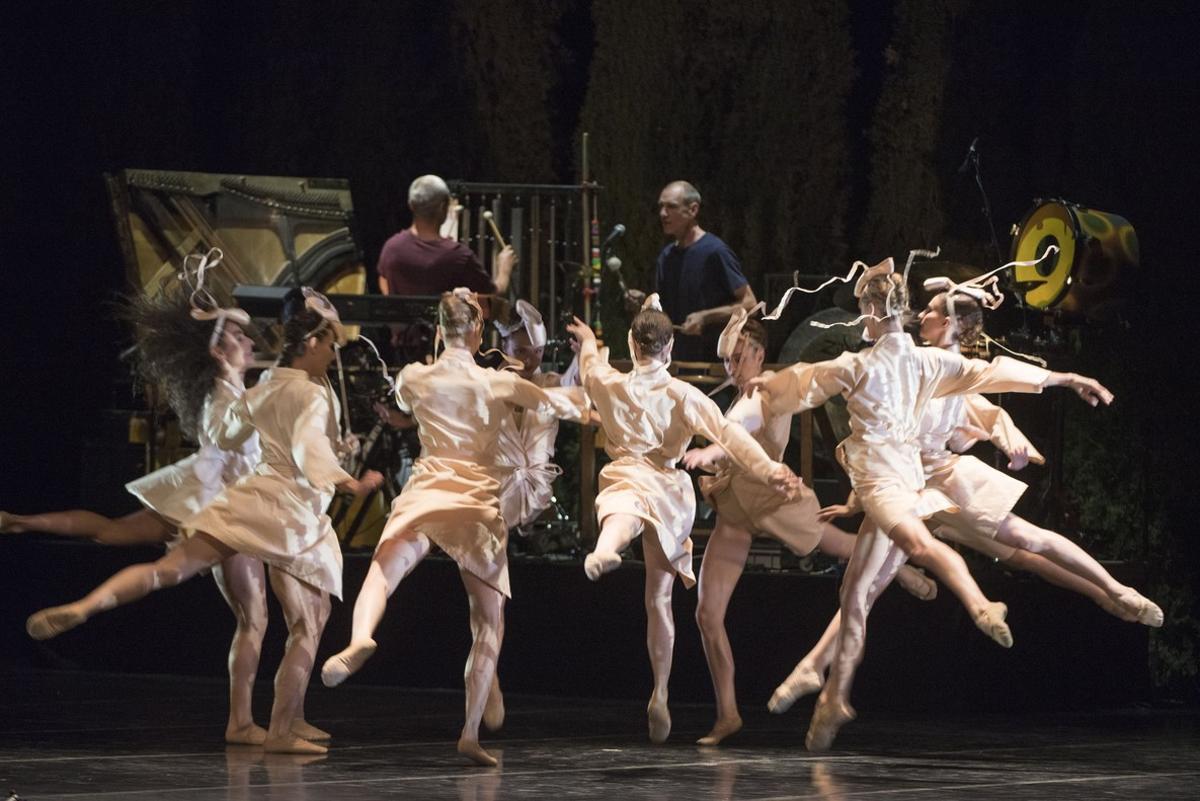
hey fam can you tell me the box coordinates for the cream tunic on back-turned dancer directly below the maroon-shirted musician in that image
[379,348,587,597]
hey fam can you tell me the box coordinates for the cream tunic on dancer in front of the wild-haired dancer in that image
[181,367,352,598]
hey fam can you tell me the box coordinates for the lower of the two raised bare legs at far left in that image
[25,532,234,639]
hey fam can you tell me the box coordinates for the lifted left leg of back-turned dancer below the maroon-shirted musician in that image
[320,531,432,687]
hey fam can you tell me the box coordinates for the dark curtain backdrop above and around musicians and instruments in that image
[0,0,1200,693]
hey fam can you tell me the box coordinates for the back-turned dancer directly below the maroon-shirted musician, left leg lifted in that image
[320,289,587,765]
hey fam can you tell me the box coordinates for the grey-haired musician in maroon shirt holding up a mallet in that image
[377,175,516,295]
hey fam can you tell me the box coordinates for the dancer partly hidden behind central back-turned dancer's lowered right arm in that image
[682,307,937,746]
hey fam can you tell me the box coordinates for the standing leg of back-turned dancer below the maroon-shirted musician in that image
[458,571,504,767]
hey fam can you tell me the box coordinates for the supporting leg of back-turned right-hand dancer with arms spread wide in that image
[805,520,905,751]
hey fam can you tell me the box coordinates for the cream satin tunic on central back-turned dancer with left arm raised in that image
[580,342,780,586]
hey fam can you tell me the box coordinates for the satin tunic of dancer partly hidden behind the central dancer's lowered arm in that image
[700,371,822,556]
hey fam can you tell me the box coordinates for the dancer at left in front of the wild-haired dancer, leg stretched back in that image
[26,290,382,753]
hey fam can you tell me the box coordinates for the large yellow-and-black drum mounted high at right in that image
[1013,199,1139,320]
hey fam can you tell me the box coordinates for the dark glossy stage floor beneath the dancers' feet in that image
[0,670,1200,801]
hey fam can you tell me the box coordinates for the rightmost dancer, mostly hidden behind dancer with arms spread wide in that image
[769,282,1163,712]
